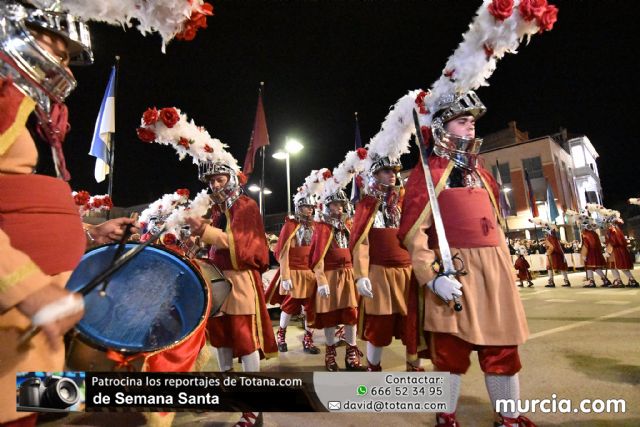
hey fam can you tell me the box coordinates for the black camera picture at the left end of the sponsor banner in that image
[18,375,80,409]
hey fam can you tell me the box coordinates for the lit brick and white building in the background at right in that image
[481,122,602,240]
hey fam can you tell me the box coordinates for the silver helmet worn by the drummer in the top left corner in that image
[0,0,93,114]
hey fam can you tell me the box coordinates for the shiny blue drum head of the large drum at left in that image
[67,244,208,353]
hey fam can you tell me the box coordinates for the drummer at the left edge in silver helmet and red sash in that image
[0,1,137,426]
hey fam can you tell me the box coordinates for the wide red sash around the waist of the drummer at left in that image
[0,175,87,275]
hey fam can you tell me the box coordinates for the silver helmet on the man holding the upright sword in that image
[431,90,487,170]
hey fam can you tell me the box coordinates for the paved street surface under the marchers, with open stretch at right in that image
[46,272,640,427]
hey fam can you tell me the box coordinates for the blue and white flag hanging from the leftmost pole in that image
[89,66,116,182]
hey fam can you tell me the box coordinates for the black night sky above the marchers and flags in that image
[65,0,640,213]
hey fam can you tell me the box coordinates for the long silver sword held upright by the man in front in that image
[413,109,467,311]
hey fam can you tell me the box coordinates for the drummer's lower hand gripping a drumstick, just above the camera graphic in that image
[17,285,84,350]
